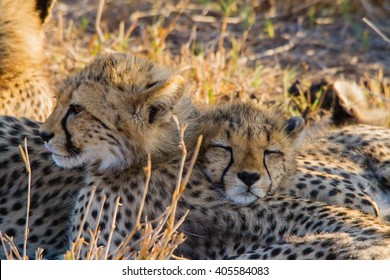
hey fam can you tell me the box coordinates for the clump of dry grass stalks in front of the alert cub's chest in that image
[64,118,202,260]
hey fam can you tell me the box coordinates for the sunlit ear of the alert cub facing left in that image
[146,75,185,124]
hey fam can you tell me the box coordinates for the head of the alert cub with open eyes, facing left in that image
[40,54,184,171]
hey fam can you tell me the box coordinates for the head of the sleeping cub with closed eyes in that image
[200,104,305,205]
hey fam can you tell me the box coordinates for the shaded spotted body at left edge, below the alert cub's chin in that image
[0,116,83,259]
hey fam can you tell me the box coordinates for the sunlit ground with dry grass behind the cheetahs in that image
[46,0,390,123]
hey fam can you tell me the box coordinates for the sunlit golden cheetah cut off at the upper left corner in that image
[0,0,54,121]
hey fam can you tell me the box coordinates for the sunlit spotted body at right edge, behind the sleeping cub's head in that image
[296,125,390,220]
